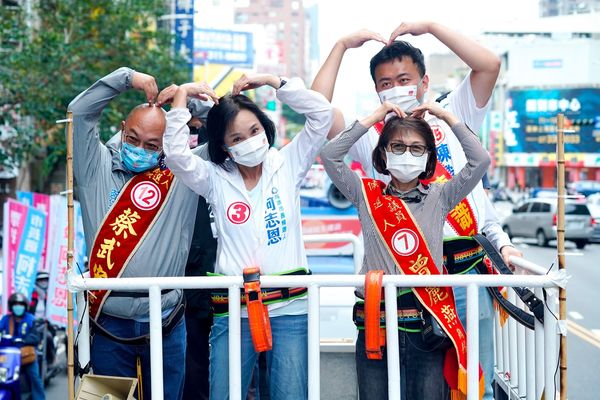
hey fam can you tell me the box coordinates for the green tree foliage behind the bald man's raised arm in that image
[0,0,188,178]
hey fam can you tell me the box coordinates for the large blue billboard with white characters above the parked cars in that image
[504,88,600,153]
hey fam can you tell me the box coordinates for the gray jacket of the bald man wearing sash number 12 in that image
[69,68,198,318]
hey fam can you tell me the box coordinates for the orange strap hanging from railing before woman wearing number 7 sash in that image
[365,270,385,360]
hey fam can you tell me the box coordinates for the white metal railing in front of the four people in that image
[68,235,566,400]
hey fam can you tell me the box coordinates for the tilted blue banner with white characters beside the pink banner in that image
[12,206,46,299]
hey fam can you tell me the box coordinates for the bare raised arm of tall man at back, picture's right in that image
[388,21,502,107]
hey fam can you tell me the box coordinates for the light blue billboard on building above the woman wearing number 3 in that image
[194,29,254,68]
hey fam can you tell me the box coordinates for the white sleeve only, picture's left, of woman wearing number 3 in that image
[163,108,213,202]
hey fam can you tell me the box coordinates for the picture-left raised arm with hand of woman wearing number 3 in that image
[161,83,218,198]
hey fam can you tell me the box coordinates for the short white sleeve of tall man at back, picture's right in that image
[441,73,491,133]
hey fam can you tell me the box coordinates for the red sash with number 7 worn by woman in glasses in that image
[363,179,484,399]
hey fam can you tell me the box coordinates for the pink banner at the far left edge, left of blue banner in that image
[1,199,28,314]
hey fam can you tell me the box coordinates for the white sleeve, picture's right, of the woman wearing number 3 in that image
[277,78,333,190]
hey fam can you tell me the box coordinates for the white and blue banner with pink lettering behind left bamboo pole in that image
[46,196,86,327]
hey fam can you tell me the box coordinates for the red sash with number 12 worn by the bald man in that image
[89,168,173,319]
